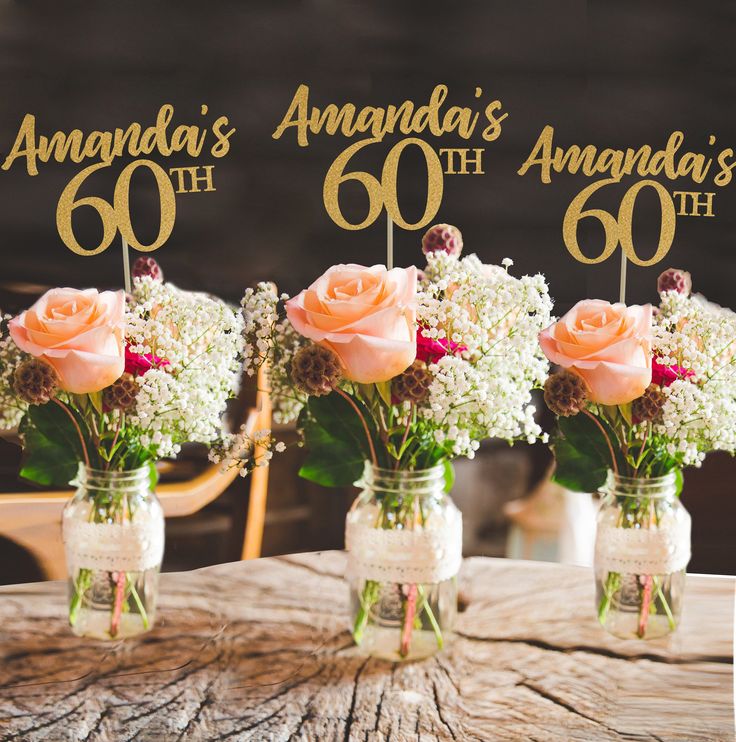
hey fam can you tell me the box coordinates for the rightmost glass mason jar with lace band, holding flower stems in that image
[595,472,690,639]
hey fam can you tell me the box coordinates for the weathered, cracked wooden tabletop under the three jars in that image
[0,552,734,742]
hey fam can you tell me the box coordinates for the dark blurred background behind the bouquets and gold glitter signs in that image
[0,0,736,573]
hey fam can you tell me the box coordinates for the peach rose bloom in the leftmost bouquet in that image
[9,288,125,394]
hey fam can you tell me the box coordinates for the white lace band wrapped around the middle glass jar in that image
[345,504,463,584]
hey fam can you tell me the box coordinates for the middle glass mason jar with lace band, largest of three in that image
[345,465,462,661]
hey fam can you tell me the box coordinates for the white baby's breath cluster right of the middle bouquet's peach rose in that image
[417,253,552,458]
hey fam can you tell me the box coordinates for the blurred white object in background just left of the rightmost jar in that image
[504,470,597,567]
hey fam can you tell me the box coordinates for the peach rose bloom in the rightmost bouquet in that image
[539,299,652,405]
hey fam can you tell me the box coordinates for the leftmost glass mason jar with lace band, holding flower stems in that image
[62,466,164,639]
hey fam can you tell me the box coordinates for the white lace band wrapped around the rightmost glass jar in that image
[595,515,690,575]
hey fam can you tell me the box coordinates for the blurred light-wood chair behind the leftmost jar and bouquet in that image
[0,367,271,580]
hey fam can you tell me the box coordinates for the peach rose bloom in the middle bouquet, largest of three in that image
[286,264,417,384]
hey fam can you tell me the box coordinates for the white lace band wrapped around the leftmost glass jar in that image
[62,516,164,572]
